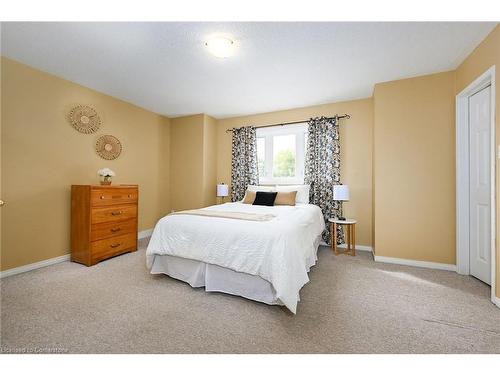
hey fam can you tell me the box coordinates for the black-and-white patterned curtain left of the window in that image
[231,126,259,202]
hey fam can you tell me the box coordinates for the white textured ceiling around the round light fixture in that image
[1,22,496,118]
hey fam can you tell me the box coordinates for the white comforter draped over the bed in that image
[146,202,325,313]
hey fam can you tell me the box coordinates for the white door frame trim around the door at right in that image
[456,65,496,302]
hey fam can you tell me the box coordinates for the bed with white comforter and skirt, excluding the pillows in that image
[146,202,325,313]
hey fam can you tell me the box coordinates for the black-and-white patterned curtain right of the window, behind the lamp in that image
[304,117,344,244]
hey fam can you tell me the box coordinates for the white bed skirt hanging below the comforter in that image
[151,237,321,305]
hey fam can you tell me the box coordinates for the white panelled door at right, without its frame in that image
[469,86,491,285]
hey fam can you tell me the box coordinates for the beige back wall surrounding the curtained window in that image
[217,99,373,246]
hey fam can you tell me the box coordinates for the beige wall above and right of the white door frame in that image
[455,26,500,298]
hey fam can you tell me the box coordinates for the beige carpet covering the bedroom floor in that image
[0,241,500,353]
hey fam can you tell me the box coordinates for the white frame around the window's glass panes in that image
[257,122,307,185]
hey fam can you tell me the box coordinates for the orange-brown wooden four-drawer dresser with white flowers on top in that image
[71,185,139,266]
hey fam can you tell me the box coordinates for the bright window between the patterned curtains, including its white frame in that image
[257,123,307,184]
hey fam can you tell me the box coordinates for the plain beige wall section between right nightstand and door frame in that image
[373,72,455,264]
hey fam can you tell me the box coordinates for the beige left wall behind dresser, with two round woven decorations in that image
[1,58,170,270]
